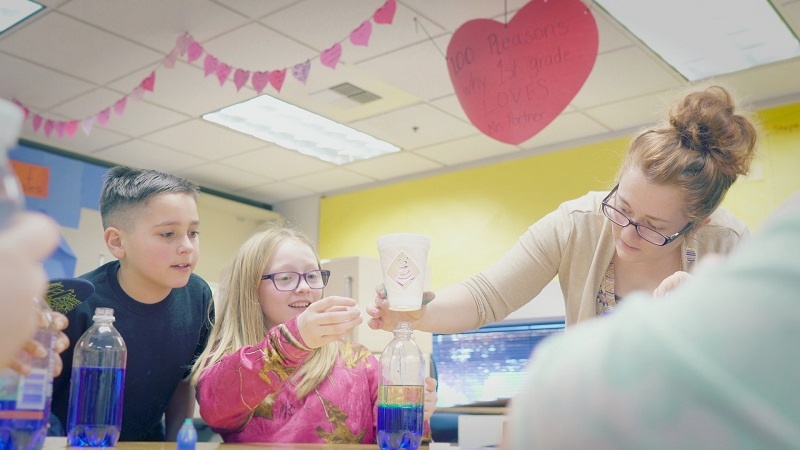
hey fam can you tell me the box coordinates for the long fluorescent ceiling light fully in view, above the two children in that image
[203,95,400,165]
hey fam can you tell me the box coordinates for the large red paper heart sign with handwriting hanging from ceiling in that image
[447,0,598,145]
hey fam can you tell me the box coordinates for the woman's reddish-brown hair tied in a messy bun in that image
[617,85,757,223]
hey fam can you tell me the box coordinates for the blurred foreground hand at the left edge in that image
[0,212,59,372]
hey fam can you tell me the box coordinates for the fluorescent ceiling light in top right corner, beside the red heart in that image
[595,0,800,81]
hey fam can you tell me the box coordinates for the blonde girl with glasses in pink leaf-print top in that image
[192,223,437,444]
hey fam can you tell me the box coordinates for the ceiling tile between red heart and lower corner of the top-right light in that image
[572,47,683,109]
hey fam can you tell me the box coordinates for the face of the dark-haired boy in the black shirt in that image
[120,193,200,301]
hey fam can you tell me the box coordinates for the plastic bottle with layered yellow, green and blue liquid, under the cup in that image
[378,322,425,450]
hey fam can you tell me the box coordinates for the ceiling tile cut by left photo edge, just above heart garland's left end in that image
[0,53,94,109]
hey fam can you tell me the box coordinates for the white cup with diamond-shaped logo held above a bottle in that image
[378,233,431,311]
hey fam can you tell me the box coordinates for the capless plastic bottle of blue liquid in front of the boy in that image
[67,308,128,447]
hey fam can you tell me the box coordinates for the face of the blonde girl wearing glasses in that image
[258,239,322,328]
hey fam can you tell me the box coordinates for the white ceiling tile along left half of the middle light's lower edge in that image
[144,119,269,161]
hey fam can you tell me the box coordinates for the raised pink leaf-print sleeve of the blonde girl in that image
[197,318,312,431]
